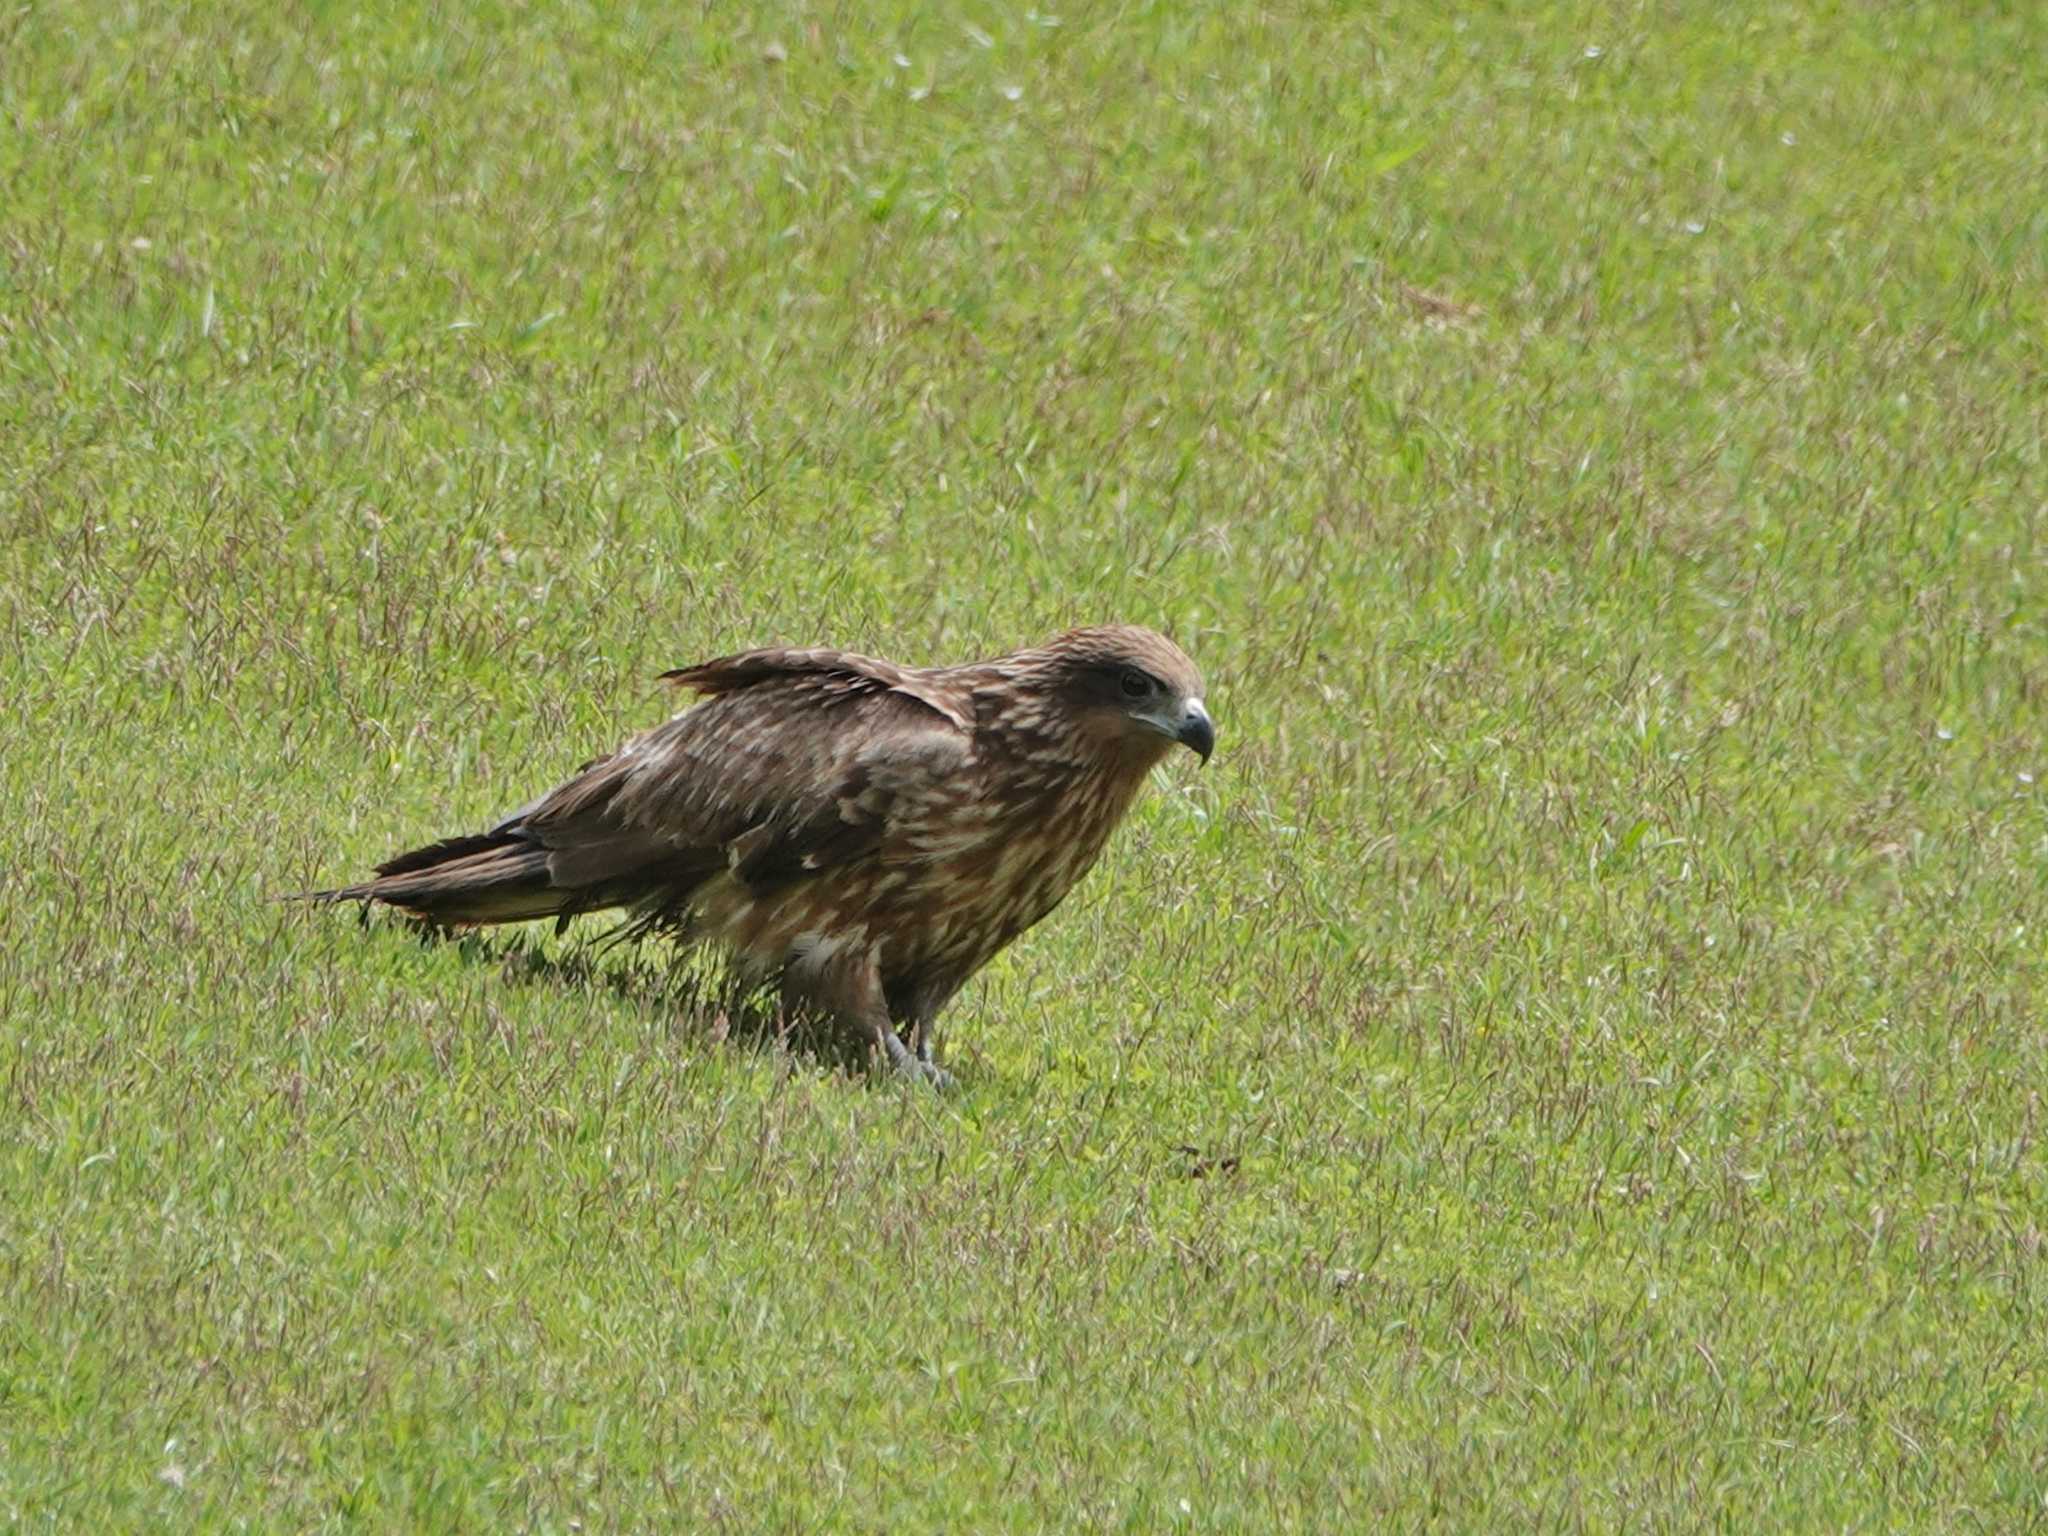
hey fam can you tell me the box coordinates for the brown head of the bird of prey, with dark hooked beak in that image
[1040,625,1217,766]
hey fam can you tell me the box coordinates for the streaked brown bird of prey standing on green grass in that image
[296,625,1217,1081]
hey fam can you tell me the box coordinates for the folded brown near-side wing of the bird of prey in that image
[496,651,969,899]
